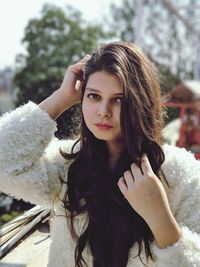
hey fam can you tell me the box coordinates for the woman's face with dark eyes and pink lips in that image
[82,71,123,141]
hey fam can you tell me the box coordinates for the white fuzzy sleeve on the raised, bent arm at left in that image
[0,101,74,208]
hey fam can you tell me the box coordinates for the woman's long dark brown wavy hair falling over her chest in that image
[60,42,167,267]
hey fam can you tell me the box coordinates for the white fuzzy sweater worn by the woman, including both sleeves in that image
[0,102,200,267]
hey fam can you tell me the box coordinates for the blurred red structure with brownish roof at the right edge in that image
[164,81,200,159]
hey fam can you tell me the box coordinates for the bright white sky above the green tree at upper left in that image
[0,0,121,69]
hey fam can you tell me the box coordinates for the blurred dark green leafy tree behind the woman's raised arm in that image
[14,5,110,137]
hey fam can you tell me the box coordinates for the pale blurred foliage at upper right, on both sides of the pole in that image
[109,0,195,82]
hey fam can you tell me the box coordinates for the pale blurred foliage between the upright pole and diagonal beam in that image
[144,0,195,80]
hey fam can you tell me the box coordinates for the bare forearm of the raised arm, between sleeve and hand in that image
[39,89,75,120]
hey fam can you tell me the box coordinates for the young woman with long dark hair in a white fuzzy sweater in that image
[0,42,200,267]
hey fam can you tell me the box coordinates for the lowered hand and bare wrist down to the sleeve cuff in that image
[118,155,181,248]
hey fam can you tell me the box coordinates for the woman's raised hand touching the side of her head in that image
[59,55,90,104]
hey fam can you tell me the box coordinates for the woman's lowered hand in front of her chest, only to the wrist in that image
[118,154,172,228]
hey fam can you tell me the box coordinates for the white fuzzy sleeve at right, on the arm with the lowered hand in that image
[152,145,200,267]
